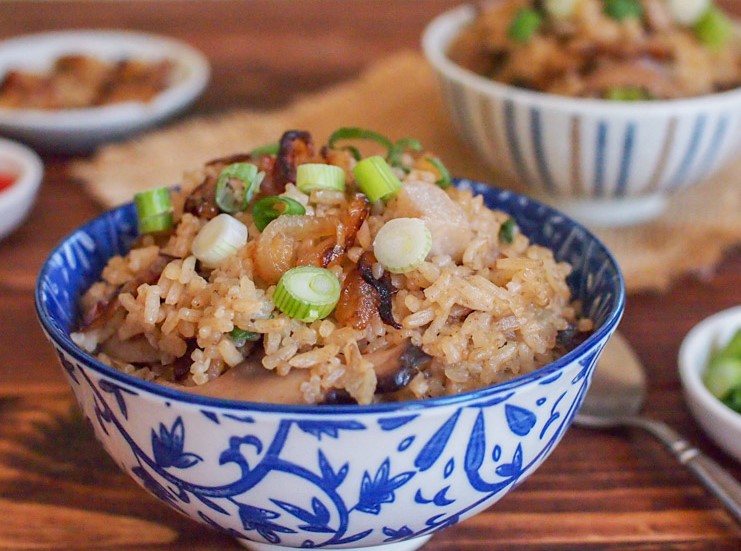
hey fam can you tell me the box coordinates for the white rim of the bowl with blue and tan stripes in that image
[422,4,741,117]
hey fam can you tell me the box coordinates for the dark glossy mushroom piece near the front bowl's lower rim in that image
[365,340,432,394]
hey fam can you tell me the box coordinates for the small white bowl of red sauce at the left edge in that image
[0,138,44,239]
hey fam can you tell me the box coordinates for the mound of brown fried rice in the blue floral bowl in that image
[72,129,592,404]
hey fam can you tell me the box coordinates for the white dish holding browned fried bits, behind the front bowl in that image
[0,31,211,154]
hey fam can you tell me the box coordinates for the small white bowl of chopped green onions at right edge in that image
[679,306,741,462]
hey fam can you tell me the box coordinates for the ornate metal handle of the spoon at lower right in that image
[636,418,741,524]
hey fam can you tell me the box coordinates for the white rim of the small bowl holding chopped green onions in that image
[677,305,741,429]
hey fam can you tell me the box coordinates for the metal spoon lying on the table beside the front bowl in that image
[574,333,741,524]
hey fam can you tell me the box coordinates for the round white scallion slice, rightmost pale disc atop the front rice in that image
[373,218,432,274]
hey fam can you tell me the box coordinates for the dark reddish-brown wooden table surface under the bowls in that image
[0,0,741,551]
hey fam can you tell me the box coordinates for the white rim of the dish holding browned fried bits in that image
[0,29,211,131]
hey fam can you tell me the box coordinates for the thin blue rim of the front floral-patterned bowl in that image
[34,178,626,417]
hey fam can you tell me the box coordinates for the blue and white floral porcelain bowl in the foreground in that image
[36,181,624,551]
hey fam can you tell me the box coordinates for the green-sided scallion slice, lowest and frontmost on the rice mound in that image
[273,266,341,322]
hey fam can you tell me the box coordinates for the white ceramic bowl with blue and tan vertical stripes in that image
[423,5,741,225]
